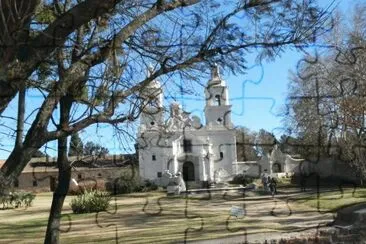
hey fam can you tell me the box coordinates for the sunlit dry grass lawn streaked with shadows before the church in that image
[0,189,366,243]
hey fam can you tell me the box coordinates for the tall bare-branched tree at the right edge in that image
[285,3,366,175]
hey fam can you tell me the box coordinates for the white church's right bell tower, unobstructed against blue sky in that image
[205,64,232,128]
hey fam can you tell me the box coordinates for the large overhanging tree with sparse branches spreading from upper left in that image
[0,0,329,187]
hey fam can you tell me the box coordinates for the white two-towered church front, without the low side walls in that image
[137,66,238,183]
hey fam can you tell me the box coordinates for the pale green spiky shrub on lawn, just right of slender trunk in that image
[70,190,111,214]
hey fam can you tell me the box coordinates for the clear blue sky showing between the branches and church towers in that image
[0,0,357,159]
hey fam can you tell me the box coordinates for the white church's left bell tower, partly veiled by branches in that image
[140,67,164,129]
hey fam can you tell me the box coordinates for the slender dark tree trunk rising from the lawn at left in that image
[44,97,72,244]
